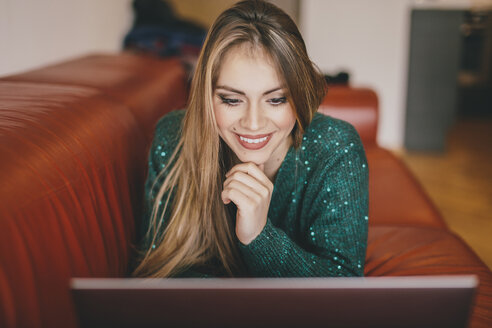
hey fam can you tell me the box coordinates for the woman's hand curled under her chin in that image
[221,163,273,245]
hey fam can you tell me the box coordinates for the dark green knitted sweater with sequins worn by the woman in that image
[141,110,368,277]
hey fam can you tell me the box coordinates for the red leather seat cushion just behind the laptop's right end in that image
[365,226,492,328]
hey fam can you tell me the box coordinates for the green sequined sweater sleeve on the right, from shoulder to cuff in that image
[239,131,368,277]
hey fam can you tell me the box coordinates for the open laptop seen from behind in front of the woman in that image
[71,276,478,328]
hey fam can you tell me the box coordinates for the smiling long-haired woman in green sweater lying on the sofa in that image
[134,1,368,277]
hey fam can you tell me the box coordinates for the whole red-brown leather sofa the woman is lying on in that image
[0,53,492,327]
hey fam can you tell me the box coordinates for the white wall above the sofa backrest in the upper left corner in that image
[0,0,133,76]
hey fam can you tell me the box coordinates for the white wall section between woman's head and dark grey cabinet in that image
[300,0,411,149]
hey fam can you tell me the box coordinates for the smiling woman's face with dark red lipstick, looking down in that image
[213,46,296,168]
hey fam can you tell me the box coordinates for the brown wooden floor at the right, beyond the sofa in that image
[396,119,492,268]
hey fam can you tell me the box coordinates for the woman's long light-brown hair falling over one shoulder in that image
[134,1,325,277]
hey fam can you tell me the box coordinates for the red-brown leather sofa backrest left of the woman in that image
[0,54,186,327]
